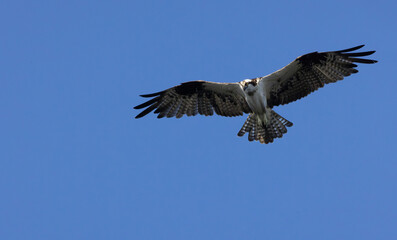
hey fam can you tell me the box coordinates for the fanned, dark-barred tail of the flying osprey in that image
[237,110,292,144]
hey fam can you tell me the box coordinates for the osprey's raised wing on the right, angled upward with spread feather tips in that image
[262,45,377,107]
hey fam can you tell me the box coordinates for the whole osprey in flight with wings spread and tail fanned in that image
[134,45,377,143]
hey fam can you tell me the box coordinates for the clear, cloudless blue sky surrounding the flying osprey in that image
[0,0,397,240]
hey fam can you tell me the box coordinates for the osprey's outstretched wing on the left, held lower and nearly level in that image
[134,81,251,118]
